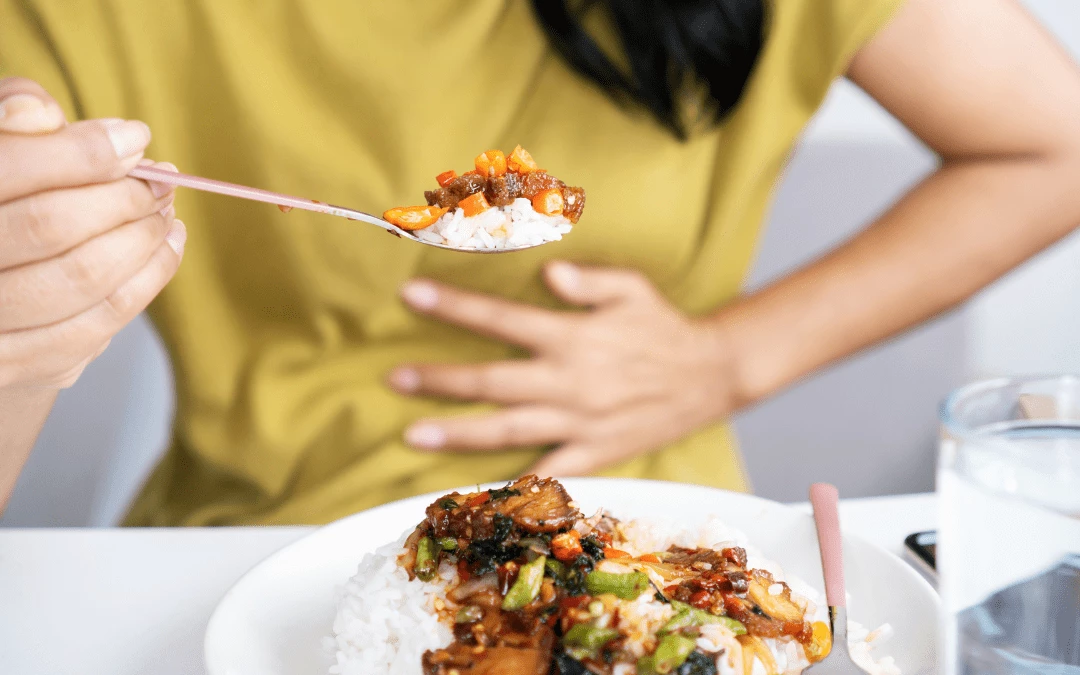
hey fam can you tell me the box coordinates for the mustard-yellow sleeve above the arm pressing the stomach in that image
[767,0,904,107]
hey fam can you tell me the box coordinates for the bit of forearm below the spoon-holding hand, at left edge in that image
[0,389,57,513]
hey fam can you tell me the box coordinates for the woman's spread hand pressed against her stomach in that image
[390,262,735,475]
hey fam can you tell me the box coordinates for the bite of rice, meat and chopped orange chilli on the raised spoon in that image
[382,146,585,249]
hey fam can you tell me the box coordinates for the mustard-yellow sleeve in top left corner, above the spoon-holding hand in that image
[0,0,79,119]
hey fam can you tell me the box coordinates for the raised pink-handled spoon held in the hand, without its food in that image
[127,166,540,253]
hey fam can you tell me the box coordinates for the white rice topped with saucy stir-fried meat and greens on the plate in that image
[330,476,899,675]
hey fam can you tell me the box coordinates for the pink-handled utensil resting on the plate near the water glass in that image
[802,483,866,675]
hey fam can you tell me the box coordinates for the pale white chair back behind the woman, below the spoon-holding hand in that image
[0,316,175,527]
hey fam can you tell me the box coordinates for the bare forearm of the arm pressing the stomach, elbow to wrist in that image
[715,152,1080,406]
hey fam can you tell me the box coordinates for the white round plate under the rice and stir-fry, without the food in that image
[205,478,939,675]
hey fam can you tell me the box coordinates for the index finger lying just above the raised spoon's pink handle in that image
[0,120,150,203]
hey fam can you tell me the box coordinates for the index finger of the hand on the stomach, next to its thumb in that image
[402,280,568,348]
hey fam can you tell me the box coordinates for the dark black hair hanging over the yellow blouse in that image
[532,0,765,137]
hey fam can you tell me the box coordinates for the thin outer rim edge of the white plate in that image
[202,476,941,672]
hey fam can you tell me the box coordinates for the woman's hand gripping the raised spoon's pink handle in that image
[0,78,185,392]
